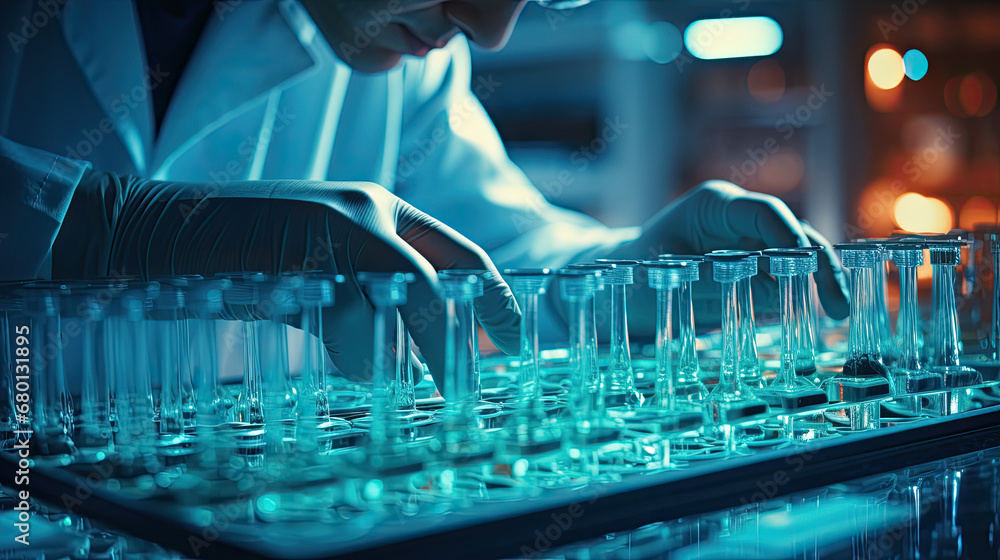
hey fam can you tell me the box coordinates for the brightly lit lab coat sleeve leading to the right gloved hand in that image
[396,36,639,336]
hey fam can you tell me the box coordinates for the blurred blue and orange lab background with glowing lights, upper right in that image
[473,0,1000,245]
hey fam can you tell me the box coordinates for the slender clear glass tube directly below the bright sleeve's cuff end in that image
[594,259,642,408]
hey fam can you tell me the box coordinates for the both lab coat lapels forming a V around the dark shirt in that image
[63,0,316,176]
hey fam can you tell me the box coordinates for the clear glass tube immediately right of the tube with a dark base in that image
[885,240,942,394]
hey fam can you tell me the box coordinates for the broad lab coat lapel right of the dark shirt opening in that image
[152,1,315,175]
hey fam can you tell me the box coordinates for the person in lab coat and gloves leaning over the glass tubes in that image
[0,0,847,376]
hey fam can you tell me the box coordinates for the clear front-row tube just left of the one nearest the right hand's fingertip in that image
[705,251,768,424]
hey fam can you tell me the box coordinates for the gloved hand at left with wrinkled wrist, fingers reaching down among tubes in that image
[53,172,521,382]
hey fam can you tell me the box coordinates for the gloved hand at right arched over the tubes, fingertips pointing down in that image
[610,181,849,333]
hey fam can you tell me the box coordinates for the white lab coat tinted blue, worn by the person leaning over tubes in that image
[0,0,635,286]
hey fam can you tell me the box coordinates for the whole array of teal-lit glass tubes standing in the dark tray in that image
[0,230,1000,486]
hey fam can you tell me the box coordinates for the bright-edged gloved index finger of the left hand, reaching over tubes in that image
[396,201,521,354]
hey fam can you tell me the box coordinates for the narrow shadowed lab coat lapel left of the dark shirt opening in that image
[62,0,156,174]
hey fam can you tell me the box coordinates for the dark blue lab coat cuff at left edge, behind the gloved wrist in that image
[0,132,90,280]
